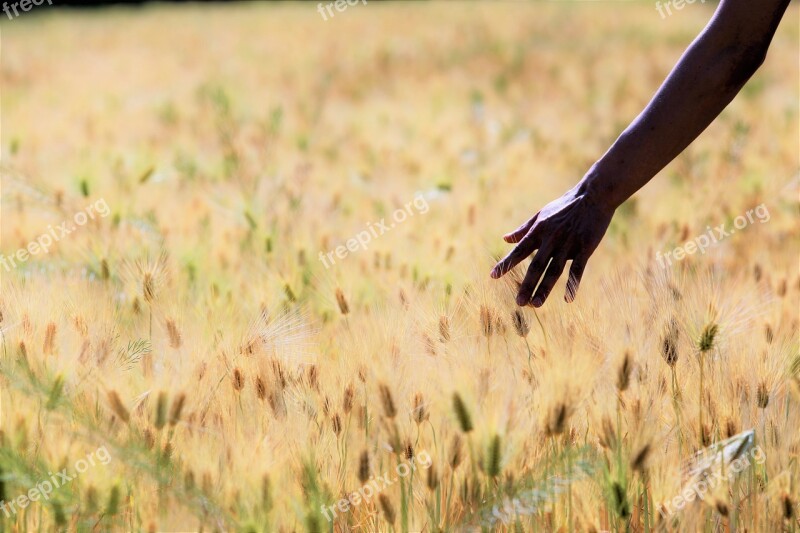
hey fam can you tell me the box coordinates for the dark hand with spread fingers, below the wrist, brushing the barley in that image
[491,186,614,307]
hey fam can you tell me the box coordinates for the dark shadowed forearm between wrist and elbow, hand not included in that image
[579,0,785,208]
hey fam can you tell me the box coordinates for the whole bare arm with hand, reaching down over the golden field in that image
[491,0,789,307]
